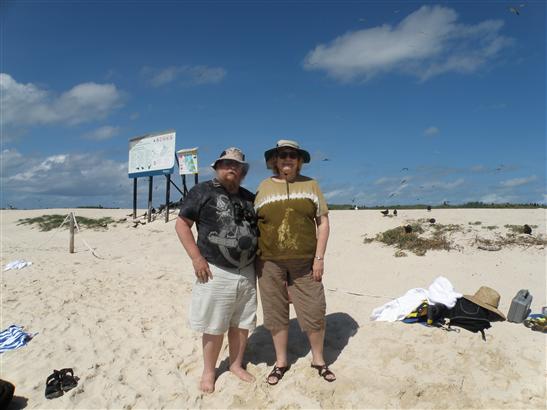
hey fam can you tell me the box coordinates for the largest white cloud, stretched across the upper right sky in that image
[304,6,513,82]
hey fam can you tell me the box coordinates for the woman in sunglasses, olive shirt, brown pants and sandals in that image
[255,140,336,385]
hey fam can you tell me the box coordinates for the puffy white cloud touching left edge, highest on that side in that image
[0,73,122,126]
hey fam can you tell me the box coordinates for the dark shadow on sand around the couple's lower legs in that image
[217,312,359,377]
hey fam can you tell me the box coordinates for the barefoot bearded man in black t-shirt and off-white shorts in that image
[175,148,258,393]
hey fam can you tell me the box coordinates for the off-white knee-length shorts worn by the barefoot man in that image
[188,263,256,335]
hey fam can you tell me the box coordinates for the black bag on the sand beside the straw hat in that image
[446,298,499,341]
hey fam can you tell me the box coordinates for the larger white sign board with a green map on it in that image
[128,132,175,176]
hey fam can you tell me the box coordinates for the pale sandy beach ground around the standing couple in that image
[0,209,547,409]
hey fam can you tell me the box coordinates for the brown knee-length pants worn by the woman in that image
[256,258,326,332]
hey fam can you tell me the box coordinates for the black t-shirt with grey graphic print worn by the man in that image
[179,179,258,268]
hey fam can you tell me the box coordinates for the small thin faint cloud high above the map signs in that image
[141,65,226,87]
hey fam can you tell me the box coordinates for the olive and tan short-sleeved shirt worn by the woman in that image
[255,175,329,260]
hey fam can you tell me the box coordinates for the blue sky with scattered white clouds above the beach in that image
[0,1,547,208]
